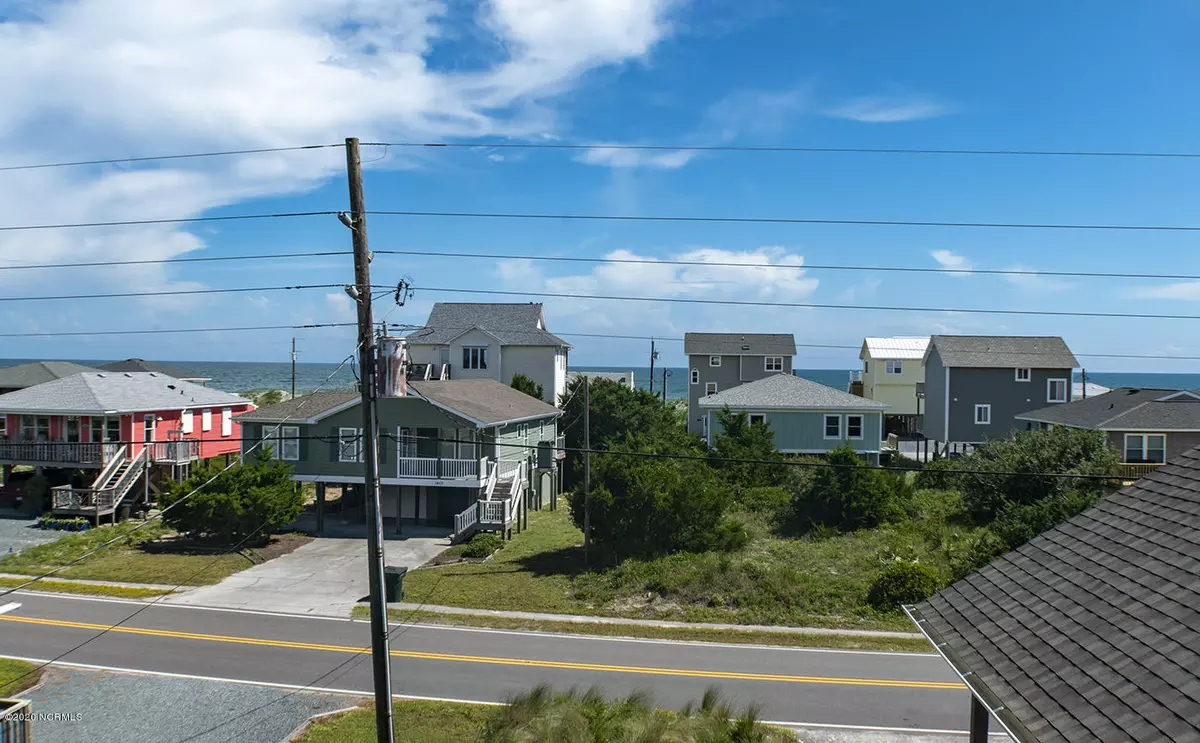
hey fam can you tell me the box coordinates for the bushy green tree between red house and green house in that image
[158,449,304,544]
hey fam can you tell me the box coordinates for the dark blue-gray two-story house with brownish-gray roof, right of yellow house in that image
[922,335,1079,444]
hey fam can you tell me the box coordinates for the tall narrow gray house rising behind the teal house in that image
[683,332,796,436]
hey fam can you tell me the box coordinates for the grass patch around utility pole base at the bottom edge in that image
[294,701,491,743]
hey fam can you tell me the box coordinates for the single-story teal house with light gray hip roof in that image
[698,375,888,462]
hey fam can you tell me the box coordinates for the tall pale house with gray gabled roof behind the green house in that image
[407,302,571,405]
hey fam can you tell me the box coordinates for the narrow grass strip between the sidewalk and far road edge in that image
[353,606,931,653]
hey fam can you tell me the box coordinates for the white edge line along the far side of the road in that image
[7,591,940,658]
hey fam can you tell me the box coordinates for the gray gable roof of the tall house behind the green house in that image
[406,301,570,348]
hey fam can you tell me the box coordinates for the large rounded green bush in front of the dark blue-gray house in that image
[956,426,1120,523]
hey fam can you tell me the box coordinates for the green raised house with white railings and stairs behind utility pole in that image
[238,379,562,537]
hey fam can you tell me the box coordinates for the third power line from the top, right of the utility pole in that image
[374,250,1200,281]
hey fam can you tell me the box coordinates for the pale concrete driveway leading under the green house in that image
[164,527,450,617]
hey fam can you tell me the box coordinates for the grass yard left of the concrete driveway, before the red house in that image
[0,521,307,586]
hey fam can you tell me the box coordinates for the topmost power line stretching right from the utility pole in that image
[364,142,1200,158]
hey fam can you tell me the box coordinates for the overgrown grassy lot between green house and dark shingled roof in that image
[404,491,973,631]
